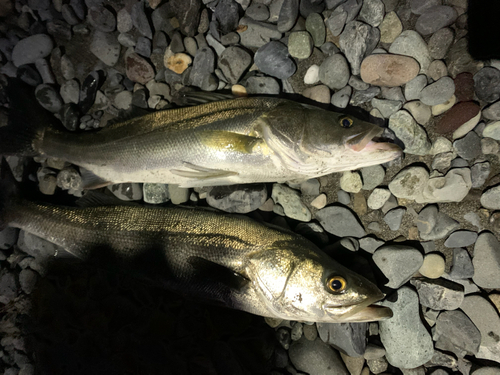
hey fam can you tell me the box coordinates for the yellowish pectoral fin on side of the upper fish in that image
[198,130,263,154]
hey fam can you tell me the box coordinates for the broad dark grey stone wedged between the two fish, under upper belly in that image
[207,184,270,214]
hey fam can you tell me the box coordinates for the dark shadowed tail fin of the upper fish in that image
[0,78,54,156]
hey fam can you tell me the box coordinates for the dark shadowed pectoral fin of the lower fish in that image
[188,256,250,290]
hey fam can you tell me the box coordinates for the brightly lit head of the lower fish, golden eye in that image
[247,244,392,323]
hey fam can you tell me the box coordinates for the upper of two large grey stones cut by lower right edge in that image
[472,232,500,288]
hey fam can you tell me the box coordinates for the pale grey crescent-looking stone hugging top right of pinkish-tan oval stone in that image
[389,30,432,74]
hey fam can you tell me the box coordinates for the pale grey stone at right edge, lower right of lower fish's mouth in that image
[460,296,500,362]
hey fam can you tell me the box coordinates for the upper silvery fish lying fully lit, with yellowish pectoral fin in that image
[0,81,401,189]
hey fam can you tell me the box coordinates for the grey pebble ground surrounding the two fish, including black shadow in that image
[0,0,500,375]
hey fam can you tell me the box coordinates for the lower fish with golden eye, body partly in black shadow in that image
[0,181,392,323]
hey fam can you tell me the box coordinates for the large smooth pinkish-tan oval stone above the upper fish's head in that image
[361,54,420,87]
